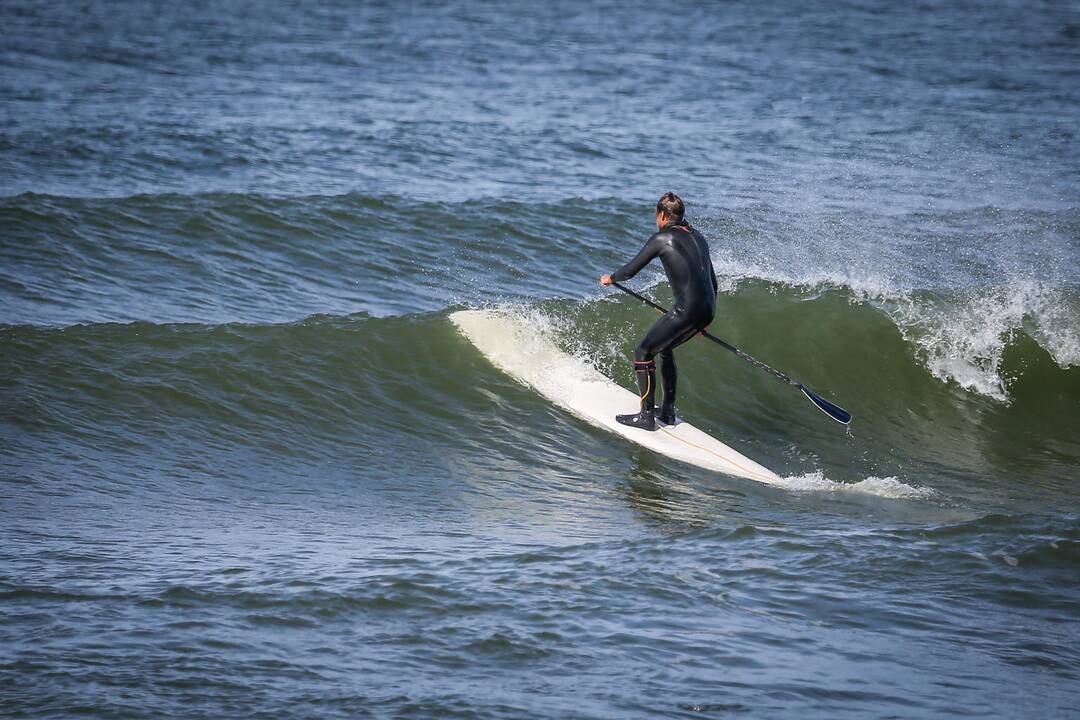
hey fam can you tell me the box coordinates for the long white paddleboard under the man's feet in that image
[450,310,782,484]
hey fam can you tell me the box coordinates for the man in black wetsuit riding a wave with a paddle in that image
[600,192,717,430]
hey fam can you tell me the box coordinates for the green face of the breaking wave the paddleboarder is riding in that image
[2,293,1080,512]
